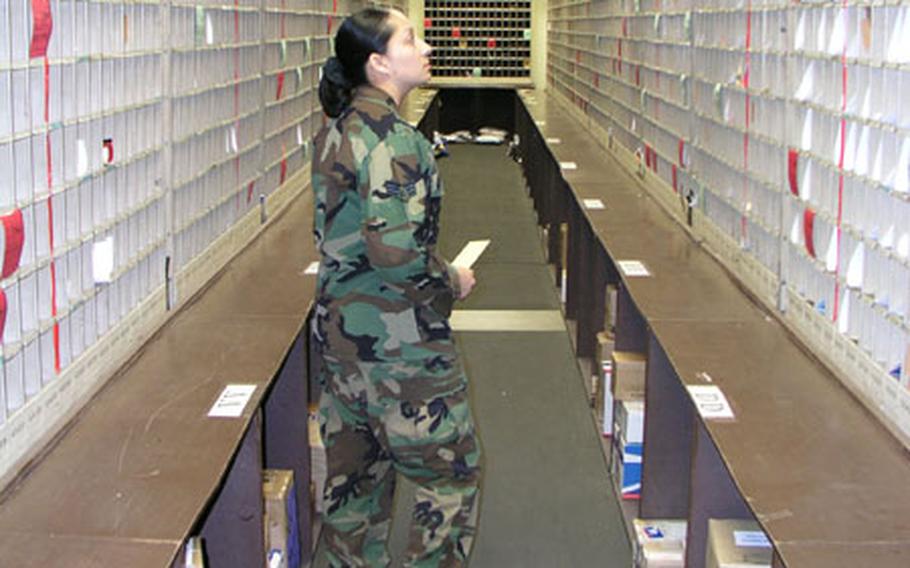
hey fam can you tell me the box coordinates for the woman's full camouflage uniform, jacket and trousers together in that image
[312,86,480,566]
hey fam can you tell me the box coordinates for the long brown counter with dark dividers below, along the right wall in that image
[516,90,910,568]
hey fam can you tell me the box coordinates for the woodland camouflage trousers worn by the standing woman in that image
[319,355,480,568]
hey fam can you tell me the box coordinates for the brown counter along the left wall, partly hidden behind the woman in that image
[0,91,439,568]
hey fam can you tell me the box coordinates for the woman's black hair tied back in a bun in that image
[319,8,395,118]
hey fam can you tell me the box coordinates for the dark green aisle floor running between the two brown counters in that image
[314,145,631,568]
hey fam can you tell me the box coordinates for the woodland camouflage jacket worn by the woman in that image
[312,86,458,361]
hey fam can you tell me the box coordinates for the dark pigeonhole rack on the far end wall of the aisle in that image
[424,0,531,78]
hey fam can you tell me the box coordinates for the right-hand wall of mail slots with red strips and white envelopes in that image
[547,0,910,442]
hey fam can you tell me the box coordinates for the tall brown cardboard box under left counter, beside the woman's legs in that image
[262,469,301,568]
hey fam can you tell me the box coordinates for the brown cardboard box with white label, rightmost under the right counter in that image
[705,519,774,568]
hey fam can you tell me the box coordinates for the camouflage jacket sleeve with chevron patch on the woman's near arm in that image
[362,132,458,304]
